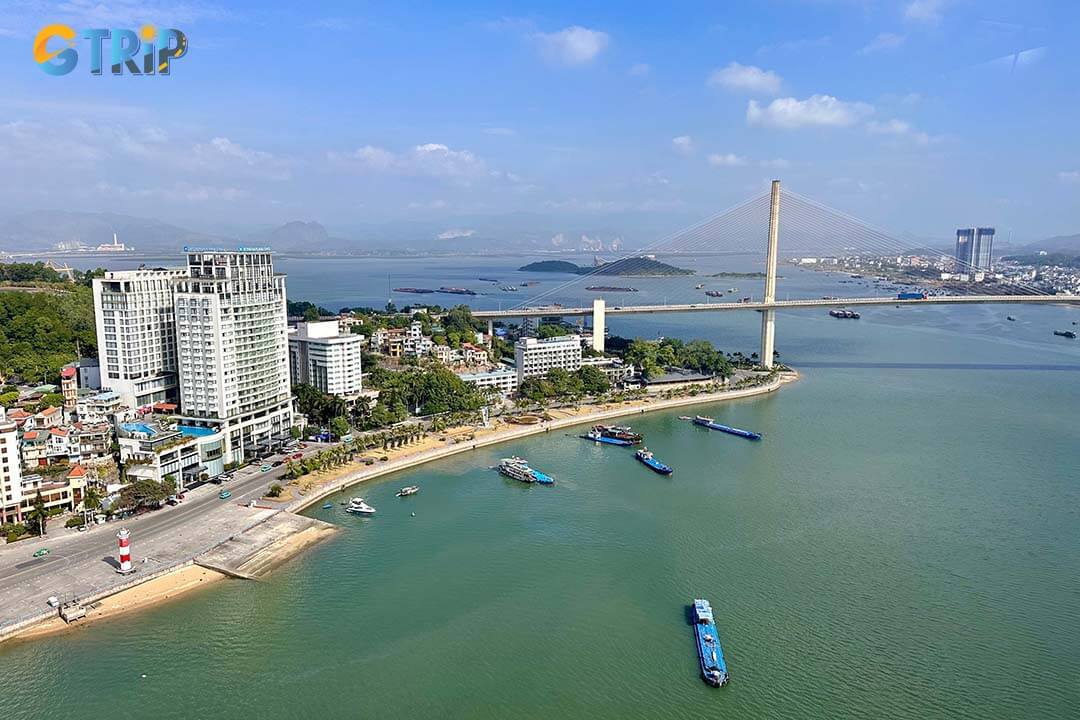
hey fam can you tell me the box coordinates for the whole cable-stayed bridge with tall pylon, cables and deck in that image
[473,180,1080,367]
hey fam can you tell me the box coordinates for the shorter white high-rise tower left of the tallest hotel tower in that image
[94,268,186,408]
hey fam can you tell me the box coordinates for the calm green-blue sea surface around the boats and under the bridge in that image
[0,253,1080,719]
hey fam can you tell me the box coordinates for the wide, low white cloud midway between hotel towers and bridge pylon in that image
[327,142,490,182]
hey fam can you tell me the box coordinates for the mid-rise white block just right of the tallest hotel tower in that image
[288,321,364,397]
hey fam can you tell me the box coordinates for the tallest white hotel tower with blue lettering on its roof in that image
[175,248,293,462]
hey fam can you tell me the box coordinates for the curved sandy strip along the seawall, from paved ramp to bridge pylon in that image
[283,370,800,513]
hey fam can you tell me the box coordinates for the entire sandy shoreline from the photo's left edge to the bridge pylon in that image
[0,371,799,642]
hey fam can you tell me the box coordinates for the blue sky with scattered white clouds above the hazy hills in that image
[0,0,1080,241]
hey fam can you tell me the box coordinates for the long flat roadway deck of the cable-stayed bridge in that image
[473,295,1080,320]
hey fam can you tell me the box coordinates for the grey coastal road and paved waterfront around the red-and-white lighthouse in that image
[0,444,329,633]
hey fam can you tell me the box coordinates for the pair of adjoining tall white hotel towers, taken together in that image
[94,248,293,462]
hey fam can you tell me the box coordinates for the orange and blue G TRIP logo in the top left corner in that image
[33,23,188,76]
